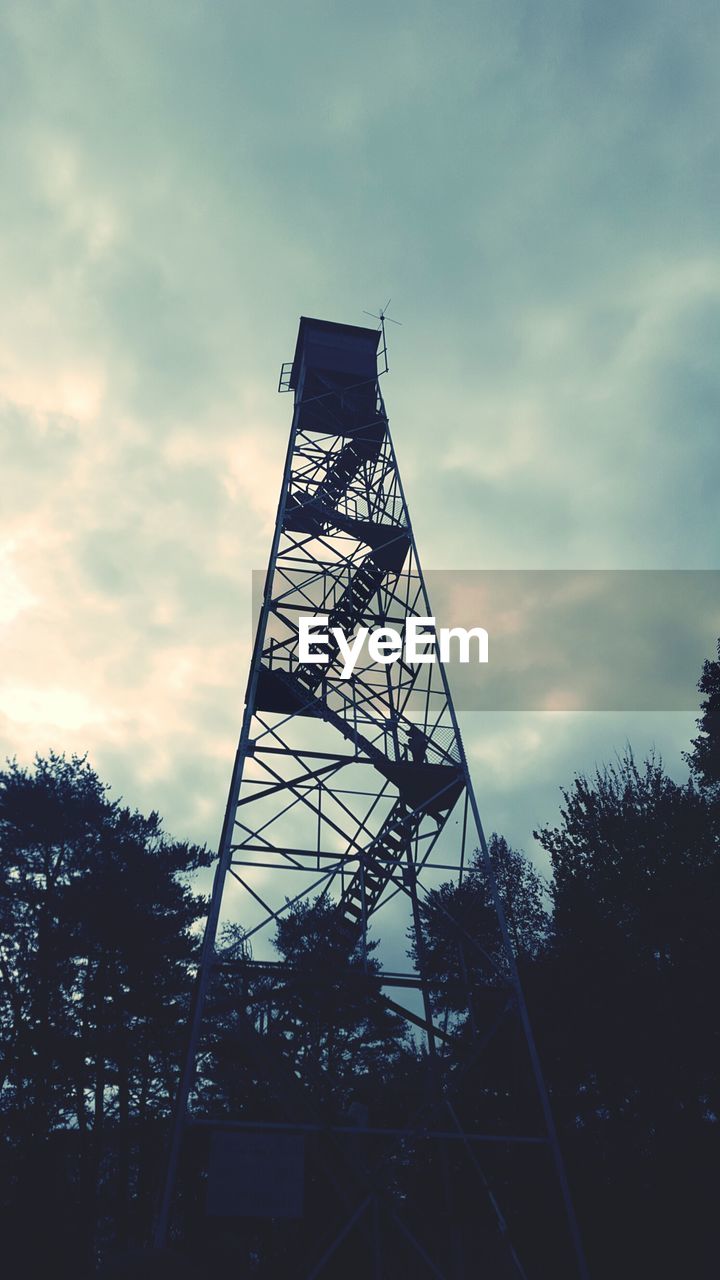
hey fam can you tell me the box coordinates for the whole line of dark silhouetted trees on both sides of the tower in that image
[0,646,720,1280]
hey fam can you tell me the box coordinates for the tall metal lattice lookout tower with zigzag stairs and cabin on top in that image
[156,317,587,1280]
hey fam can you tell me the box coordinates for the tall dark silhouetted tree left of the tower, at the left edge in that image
[0,753,209,1274]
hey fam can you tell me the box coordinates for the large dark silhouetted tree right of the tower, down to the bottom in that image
[530,751,720,1277]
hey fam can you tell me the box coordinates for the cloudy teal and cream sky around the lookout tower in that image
[0,0,720,870]
